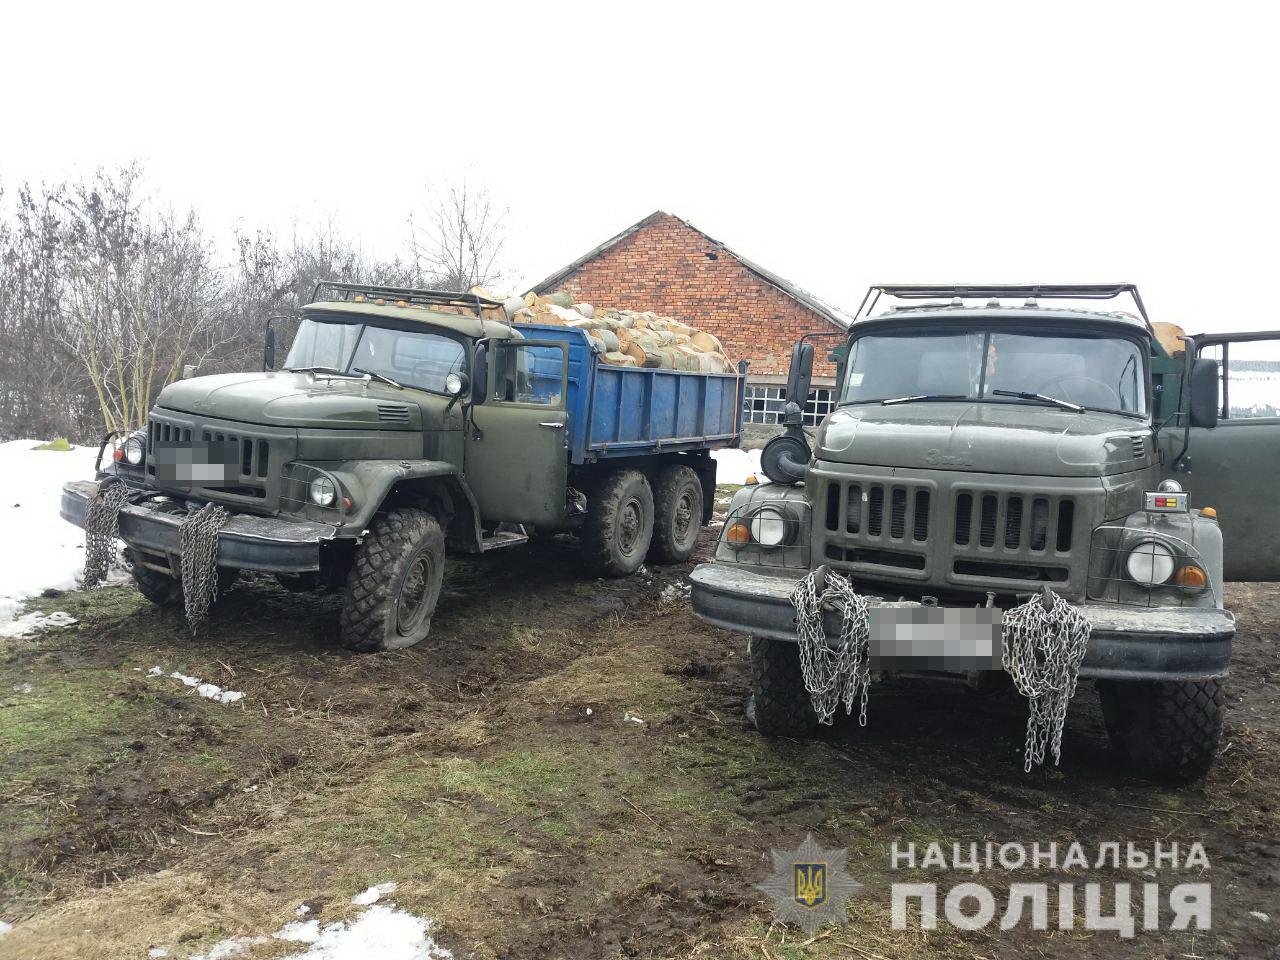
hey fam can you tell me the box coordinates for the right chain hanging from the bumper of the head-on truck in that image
[1002,588,1092,773]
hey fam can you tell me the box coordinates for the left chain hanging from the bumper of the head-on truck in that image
[791,571,870,727]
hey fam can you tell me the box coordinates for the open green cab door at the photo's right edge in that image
[1175,330,1280,580]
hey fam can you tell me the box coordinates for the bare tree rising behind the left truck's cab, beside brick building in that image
[408,179,507,293]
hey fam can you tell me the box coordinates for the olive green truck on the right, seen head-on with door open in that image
[692,284,1280,780]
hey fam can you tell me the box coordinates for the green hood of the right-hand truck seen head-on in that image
[814,401,1155,476]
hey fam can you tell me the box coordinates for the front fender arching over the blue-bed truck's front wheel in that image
[330,460,481,553]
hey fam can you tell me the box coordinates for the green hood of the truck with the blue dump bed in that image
[156,371,422,430]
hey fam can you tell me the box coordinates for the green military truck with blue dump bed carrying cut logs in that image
[61,283,742,650]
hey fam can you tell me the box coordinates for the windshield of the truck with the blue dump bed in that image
[284,317,467,393]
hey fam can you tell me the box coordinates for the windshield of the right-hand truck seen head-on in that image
[840,329,1147,416]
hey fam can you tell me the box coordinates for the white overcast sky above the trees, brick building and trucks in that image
[0,0,1280,332]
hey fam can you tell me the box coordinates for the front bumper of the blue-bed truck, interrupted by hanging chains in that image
[59,480,337,573]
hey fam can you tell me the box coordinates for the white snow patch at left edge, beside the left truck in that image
[0,440,108,625]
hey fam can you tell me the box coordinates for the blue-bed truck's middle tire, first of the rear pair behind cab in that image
[581,470,653,577]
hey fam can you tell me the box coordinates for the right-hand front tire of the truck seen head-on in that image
[1098,680,1224,783]
